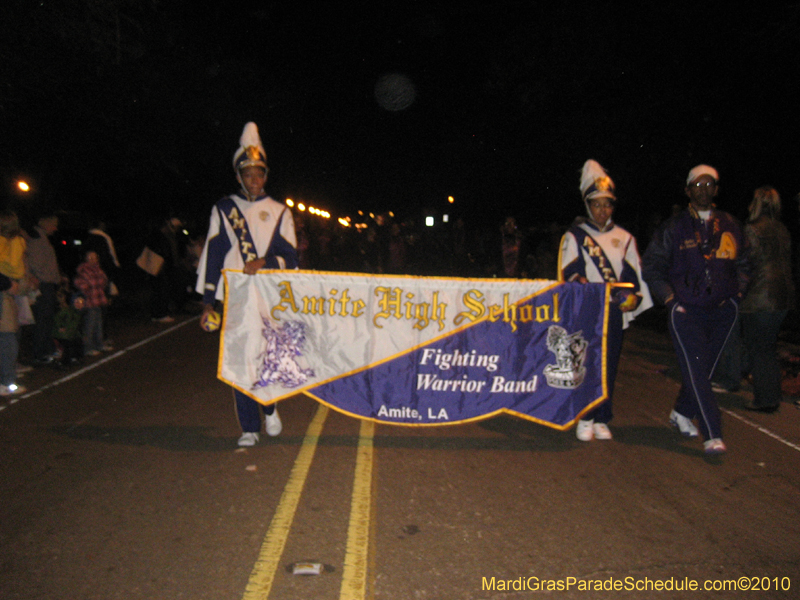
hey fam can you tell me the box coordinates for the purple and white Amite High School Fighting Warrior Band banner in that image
[218,270,609,429]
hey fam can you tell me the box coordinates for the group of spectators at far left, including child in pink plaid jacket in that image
[0,209,121,396]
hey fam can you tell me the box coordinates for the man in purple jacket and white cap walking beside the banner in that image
[642,165,748,454]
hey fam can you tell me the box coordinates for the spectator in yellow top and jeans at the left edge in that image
[0,210,26,396]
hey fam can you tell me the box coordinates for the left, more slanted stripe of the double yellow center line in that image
[242,404,328,600]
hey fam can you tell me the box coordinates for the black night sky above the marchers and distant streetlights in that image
[0,0,800,238]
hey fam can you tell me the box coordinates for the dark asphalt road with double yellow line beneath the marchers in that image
[0,310,800,600]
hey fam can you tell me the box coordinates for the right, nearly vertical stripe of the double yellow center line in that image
[339,421,375,600]
